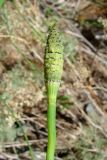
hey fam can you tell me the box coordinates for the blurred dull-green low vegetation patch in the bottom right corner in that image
[74,127,107,160]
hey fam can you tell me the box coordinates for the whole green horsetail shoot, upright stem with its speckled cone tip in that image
[44,24,63,160]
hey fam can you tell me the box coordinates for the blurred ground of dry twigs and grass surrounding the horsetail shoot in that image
[0,0,107,160]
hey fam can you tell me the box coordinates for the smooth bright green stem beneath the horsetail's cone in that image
[46,83,59,160]
